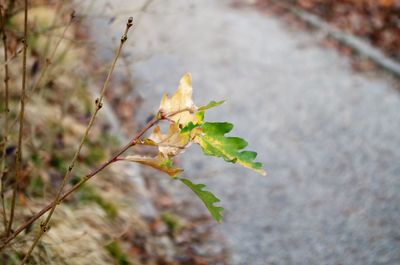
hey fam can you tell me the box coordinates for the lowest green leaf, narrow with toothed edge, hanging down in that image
[179,178,224,222]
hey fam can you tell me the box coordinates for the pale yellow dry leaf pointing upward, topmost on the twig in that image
[160,73,198,126]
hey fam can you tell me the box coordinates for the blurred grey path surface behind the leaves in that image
[81,0,400,265]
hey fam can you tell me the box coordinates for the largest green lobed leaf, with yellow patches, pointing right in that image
[195,122,266,175]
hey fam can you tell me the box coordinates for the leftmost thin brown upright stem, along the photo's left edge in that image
[0,4,10,231]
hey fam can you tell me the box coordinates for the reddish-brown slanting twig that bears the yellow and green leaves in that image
[0,105,195,251]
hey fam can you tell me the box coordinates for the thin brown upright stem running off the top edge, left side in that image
[6,0,28,235]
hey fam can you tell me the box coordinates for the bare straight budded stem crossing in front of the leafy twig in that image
[21,18,133,265]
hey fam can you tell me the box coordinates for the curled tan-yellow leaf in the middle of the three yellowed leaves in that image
[148,123,190,157]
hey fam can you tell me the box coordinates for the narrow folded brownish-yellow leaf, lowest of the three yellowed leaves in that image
[123,154,183,177]
